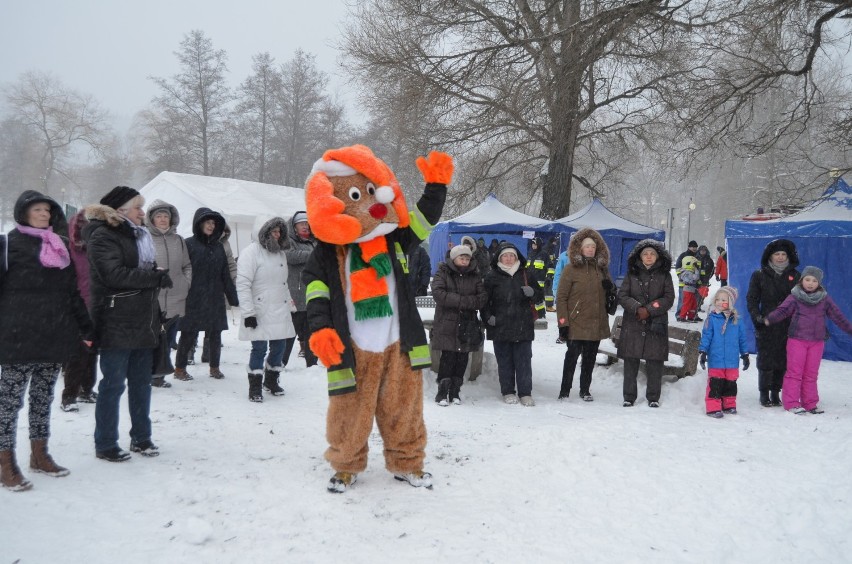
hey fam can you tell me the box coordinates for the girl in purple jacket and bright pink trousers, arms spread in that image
[764,266,852,415]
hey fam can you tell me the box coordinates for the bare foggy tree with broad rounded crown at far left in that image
[6,72,110,197]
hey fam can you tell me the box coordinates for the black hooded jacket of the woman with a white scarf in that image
[482,243,544,342]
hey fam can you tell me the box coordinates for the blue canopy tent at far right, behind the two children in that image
[725,178,852,361]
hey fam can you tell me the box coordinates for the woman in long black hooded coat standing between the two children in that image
[746,239,801,407]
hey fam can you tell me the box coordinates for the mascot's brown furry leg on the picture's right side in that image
[372,342,426,474]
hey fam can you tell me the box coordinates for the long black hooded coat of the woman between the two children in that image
[746,239,801,370]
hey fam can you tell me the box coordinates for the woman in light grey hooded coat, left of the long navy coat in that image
[145,200,192,388]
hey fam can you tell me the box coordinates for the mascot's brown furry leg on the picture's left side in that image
[325,347,382,474]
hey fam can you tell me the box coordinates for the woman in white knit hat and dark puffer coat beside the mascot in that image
[431,245,488,406]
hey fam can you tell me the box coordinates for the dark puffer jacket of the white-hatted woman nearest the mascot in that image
[431,261,488,352]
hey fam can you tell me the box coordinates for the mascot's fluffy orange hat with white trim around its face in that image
[305,145,410,245]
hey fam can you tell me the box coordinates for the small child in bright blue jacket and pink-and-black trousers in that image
[698,286,749,419]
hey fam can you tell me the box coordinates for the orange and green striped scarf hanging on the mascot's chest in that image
[349,237,393,321]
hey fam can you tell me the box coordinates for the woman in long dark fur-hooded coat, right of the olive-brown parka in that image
[618,239,675,407]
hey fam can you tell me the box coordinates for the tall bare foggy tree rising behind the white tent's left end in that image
[147,30,232,176]
